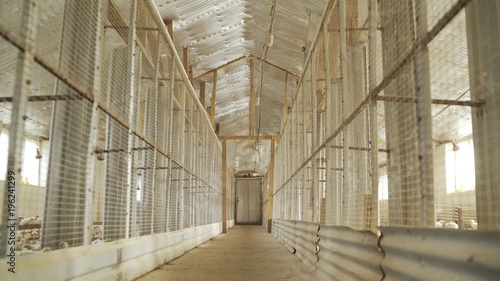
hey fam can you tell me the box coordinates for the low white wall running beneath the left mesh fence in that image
[0,223,222,281]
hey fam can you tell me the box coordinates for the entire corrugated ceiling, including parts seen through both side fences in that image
[0,0,472,175]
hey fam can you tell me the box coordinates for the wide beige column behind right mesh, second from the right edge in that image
[379,0,421,226]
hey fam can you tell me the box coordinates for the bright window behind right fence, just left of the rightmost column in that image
[445,140,476,193]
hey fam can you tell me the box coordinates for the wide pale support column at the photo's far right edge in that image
[465,1,500,231]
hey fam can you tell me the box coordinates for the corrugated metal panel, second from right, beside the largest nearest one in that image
[316,226,382,281]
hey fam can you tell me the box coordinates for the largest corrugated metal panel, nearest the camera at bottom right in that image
[380,227,500,281]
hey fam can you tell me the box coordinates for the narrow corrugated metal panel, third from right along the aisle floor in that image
[295,221,319,271]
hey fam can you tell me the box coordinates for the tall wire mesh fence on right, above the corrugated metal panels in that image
[273,0,500,231]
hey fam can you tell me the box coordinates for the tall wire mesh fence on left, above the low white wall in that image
[0,0,227,255]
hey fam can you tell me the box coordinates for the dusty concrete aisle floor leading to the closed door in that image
[136,225,318,281]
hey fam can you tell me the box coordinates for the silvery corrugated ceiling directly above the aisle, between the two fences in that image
[154,0,327,175]
